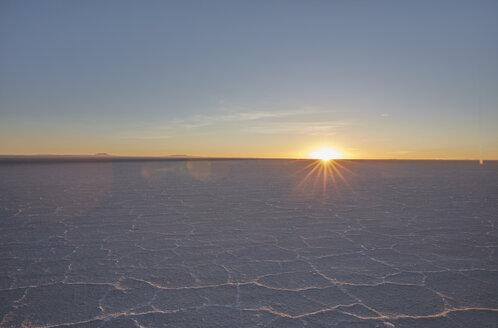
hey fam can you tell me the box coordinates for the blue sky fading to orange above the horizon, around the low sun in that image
[0,0,498,159]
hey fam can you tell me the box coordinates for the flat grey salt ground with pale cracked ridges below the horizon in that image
[0,160,498,328]
